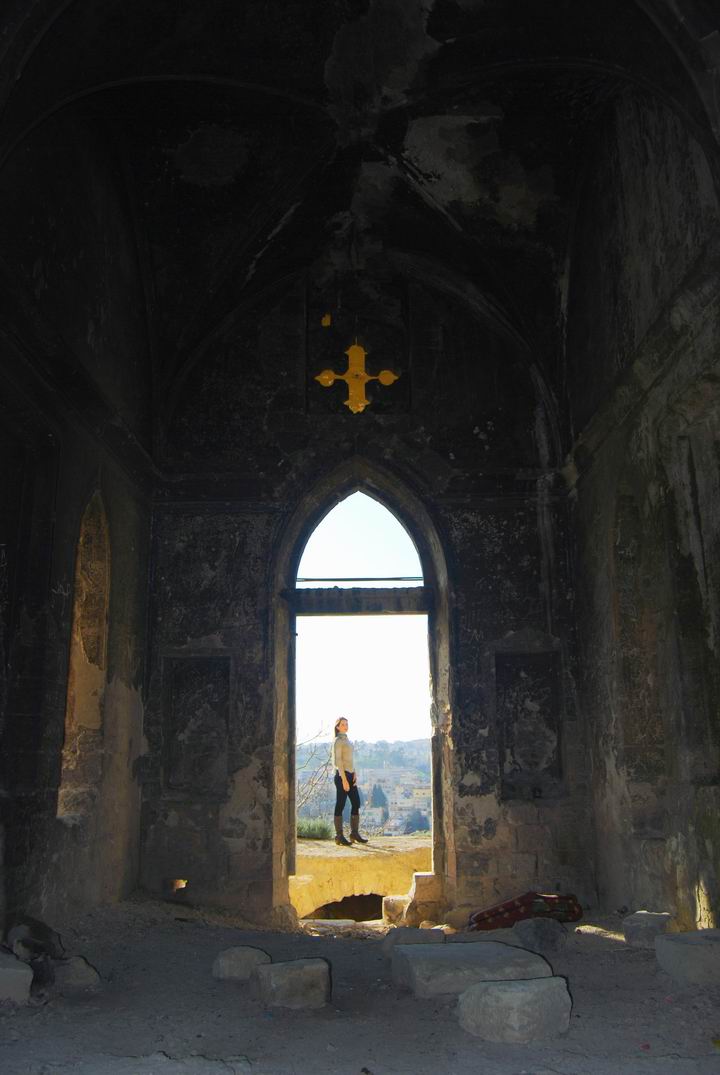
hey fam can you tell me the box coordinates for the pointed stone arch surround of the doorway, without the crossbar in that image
[273,457,456,913]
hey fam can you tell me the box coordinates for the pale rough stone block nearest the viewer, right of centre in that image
[458,977,573,1043]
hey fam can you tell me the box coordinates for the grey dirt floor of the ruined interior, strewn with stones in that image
[0,898,720,1075]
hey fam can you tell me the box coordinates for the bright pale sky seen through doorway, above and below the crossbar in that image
[296,492,431,743]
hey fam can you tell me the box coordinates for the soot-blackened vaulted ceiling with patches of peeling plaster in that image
[1,0,711,432]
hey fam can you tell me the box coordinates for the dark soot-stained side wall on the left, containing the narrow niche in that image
[0,118,150,922]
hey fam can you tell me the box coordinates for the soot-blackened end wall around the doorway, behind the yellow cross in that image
[143,273,592,914]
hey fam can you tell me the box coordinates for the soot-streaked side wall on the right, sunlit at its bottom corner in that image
[568,96,720,927]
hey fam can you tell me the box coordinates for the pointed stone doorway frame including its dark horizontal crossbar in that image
[273,460,455,917]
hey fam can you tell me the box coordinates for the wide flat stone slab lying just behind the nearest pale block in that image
[392,941,552,997]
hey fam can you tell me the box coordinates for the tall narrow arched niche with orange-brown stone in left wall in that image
[57,491,111,817]
